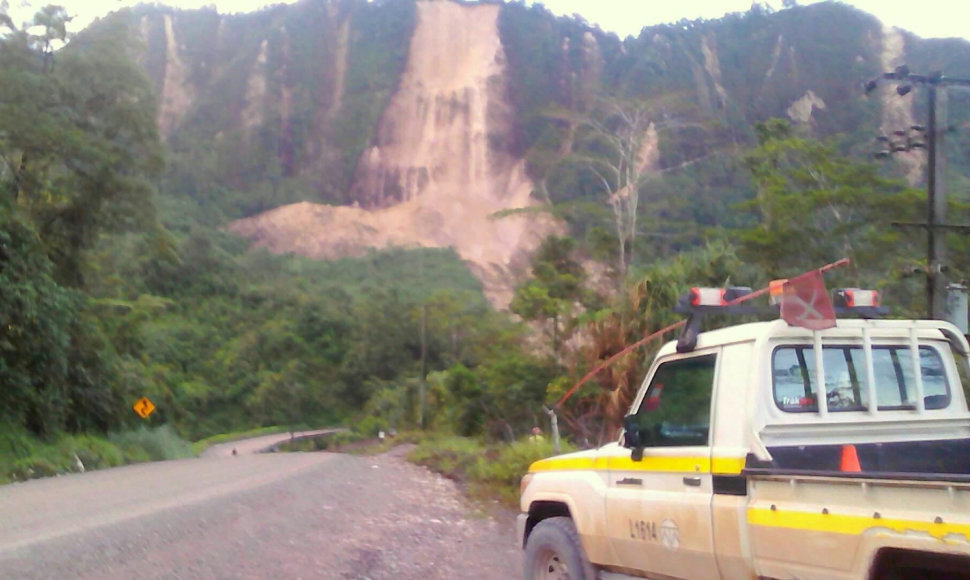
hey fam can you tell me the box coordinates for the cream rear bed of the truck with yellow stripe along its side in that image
[744,460,970,578]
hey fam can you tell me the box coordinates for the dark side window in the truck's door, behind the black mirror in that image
[633,355,716,447]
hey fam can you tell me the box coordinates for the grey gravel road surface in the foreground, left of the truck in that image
[0,450,521,580]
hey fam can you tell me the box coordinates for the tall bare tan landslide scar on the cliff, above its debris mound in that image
[351,2,528,207]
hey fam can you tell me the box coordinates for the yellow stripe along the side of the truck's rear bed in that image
[748,507,970,541]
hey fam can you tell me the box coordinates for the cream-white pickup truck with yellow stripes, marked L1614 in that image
[518,308,970,579]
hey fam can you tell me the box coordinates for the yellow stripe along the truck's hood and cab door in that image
[529,457,744,475]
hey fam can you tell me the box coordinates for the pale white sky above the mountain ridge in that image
[7,0,970,39]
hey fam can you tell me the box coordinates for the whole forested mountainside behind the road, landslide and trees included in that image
[0,0,970,472]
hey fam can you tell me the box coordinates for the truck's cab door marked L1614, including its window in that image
[606,350,718,578]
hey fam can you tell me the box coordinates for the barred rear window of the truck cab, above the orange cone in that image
[771,345,950,413]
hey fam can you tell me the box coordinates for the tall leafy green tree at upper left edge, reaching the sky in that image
[0,9,162,287]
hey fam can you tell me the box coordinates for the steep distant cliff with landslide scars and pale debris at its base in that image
[92,0,970,305]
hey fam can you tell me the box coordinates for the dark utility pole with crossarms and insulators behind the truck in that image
[865,65,970,320]
